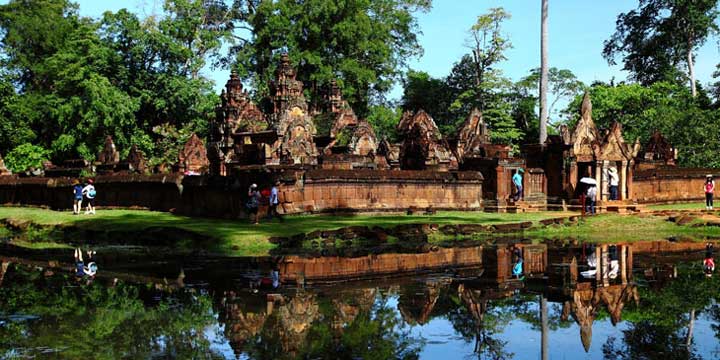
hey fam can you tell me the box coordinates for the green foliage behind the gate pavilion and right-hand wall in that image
[565,82,720,167]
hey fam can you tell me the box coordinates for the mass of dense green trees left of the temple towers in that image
[0,0,217,162]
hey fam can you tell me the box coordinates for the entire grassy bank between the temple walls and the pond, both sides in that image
[0,207,720,256]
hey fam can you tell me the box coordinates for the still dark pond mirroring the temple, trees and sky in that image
[0,241,720,359]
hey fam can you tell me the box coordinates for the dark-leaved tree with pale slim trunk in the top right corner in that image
[603,0,718,97]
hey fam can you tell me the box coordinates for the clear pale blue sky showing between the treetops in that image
[5,0,720,99]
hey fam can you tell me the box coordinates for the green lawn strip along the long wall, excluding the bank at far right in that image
[0,207,570,255]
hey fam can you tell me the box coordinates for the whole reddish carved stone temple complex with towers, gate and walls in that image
[0,54,714,217]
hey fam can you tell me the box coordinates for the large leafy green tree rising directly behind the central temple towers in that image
[231,0,430,116]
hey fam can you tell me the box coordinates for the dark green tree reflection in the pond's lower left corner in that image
[0,266,218,358]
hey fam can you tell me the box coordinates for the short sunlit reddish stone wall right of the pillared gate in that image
[632,168,720,203]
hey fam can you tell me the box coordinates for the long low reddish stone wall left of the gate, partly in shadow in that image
[0,168,482,218]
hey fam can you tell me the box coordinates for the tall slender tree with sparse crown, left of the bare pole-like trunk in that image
[467,7,512,110]
